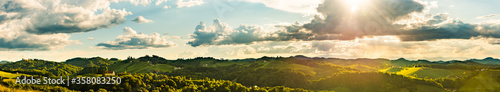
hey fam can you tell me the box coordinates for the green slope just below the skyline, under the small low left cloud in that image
[108,62,174,73]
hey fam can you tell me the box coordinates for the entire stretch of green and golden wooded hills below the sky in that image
[0,55,500,92]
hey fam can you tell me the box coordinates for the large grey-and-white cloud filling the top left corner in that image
[0,0,131,34]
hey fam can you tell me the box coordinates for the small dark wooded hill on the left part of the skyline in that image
[64,57,119,67]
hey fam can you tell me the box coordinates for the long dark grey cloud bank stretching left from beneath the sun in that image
[188,0,425,46]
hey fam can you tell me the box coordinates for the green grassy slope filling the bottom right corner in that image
[458,70,500,92]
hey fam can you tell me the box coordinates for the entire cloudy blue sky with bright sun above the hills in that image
[0,0,500,61]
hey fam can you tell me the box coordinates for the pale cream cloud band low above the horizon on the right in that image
[206,36,500,61]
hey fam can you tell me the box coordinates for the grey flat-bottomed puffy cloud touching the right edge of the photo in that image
[397,14,500,41]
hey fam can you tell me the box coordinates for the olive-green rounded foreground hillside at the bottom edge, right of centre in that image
[312,72,446,92]
